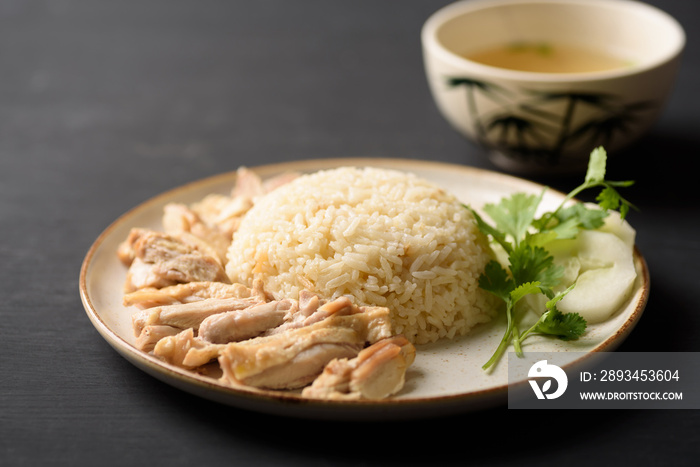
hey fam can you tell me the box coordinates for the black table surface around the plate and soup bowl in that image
[0,0,700,466]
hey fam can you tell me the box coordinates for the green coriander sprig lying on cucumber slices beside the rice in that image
[469,147,634,370]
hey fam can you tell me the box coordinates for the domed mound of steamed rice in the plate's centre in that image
[226,167,494,344]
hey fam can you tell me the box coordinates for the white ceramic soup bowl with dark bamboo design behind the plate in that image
[422,0,685,173]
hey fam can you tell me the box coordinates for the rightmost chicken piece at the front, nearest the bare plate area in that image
[302,336,416,400]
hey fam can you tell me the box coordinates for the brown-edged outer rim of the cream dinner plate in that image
[78,157,650,419]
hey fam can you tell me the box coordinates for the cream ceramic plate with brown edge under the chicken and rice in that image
[80,159,649,419]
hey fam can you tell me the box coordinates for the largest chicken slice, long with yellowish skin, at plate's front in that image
[219,307,391,389]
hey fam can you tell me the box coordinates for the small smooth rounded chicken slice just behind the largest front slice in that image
[198,300,298,344]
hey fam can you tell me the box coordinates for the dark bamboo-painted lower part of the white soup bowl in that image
[445,76,659,165]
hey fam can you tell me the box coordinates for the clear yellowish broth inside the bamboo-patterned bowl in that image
[462,43,630,73]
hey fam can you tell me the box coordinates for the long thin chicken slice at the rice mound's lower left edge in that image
[123,281,266,309]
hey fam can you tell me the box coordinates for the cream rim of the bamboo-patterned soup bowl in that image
[421,0,686,83]
